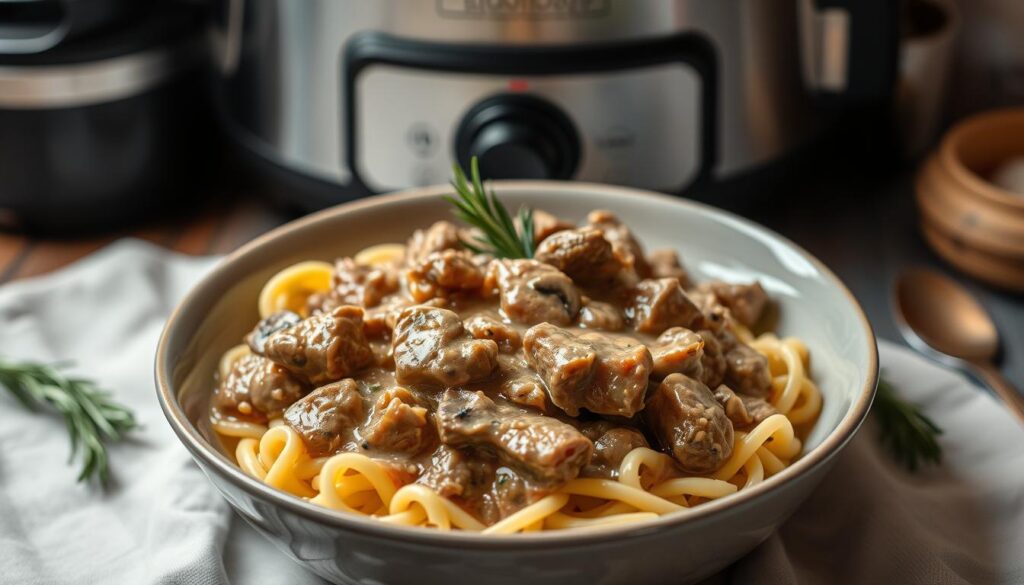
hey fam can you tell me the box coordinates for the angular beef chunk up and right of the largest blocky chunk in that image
[628,279,702,335]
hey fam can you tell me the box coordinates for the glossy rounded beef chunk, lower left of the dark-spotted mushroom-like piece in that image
[392,305,498,386]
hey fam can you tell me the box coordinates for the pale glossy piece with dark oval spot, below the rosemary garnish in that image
[483,260,582,325]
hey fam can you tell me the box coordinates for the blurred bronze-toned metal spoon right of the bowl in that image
[893,268,1024,421]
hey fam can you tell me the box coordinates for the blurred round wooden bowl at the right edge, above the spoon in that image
[916,108,1024,292]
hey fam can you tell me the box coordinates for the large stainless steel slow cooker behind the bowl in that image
[211,0,897,209]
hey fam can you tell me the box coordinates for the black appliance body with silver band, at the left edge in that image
[0,0,212,236]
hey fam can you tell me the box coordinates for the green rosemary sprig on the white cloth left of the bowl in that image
[0,360,138,485]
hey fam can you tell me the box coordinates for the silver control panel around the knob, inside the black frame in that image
[348,60,713,192]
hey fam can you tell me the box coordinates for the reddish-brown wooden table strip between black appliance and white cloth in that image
[0,198,288,285]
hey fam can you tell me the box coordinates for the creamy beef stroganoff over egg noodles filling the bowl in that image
[210,210,821,534]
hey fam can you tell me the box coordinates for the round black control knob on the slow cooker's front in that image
[456,94,580,179]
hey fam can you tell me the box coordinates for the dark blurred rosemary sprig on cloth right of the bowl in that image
[871,378,942,471]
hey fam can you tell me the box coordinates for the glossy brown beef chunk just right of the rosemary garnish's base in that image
[534,227,624,286]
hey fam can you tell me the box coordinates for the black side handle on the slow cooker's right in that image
[799,0,899,106]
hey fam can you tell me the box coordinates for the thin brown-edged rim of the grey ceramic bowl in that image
[155,180,879,551]
